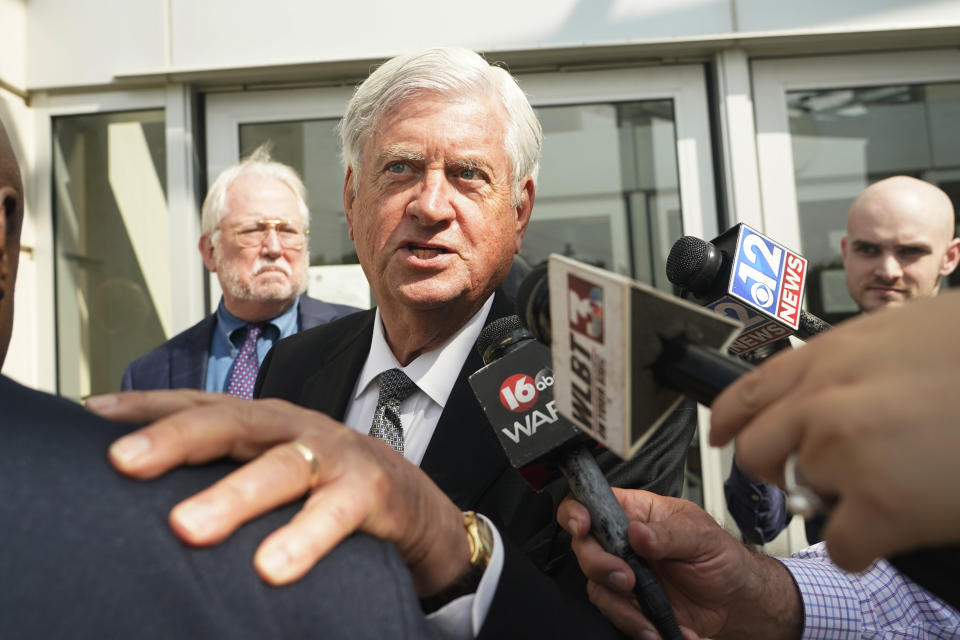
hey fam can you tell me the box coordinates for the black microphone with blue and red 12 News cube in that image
[667,223,830,354]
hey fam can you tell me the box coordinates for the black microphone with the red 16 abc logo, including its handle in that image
[470,316,682,639]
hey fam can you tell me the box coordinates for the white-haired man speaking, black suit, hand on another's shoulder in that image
[92,48,696,634]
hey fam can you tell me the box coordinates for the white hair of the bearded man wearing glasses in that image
[200,142,310,234]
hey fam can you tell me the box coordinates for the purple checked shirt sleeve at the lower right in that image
[779,543,960,640]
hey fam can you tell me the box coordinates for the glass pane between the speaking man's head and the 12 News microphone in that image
[523,100,682,290]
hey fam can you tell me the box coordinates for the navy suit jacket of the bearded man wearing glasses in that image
[120,295,358,391]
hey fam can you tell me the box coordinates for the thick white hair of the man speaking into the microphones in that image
[339,47,543,205]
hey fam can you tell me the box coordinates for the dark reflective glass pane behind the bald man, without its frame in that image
[787,83,960,322]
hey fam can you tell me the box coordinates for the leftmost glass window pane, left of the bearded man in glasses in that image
[53,110,171,398]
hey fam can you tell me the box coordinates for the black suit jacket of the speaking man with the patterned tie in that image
[254,292,696,636]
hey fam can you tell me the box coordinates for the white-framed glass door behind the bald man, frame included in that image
[753,50,960,322]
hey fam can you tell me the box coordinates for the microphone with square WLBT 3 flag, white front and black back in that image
[517,254,749,459]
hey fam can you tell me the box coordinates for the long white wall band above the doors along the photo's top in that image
[24,0,960,89]
